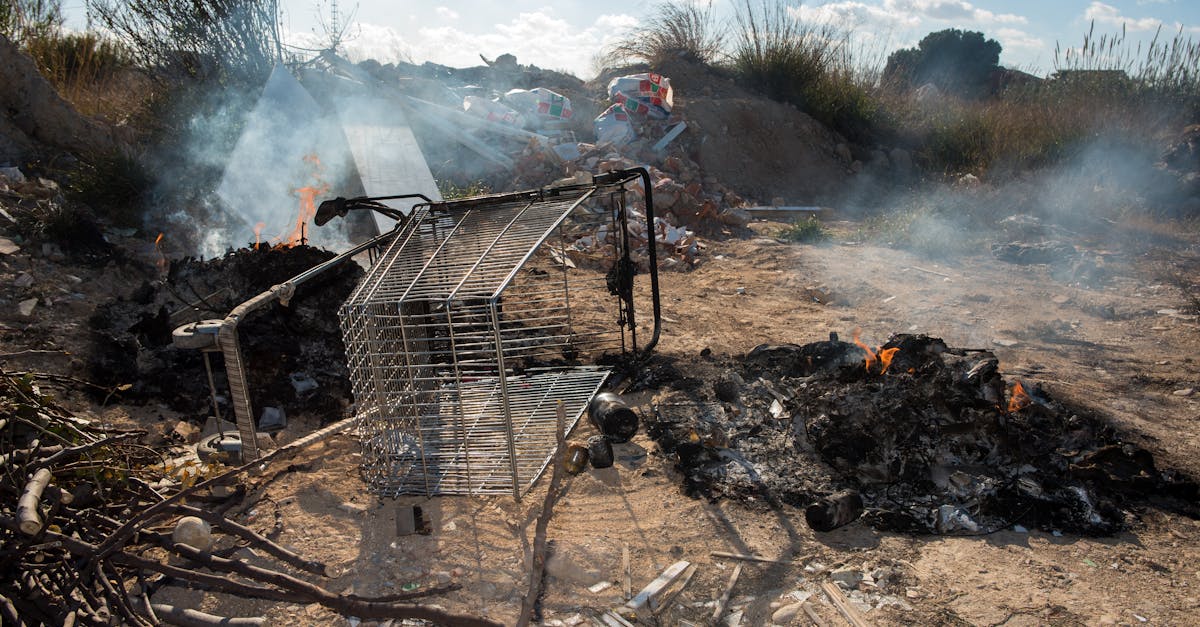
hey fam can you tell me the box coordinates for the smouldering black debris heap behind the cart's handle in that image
[89,245,362,416]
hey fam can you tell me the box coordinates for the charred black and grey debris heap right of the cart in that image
[649,335,1200,535]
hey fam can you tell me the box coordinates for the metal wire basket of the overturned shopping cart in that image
[340,168,660,498]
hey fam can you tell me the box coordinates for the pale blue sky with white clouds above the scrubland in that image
[64,0,1200,78]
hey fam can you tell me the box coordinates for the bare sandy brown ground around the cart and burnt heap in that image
[5,212,1200,626]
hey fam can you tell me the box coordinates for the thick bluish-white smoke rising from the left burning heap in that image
[148,66,361,257]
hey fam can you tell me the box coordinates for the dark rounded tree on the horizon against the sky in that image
[883,29,1001,97]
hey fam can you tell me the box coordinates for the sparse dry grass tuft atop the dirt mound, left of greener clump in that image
[604,0,725,65]
